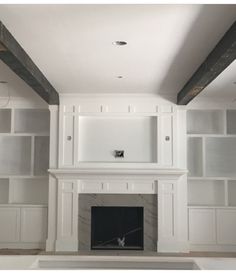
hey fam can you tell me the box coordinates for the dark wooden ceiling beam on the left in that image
[0,21,59,105]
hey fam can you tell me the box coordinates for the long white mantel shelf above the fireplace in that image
[48,168,187,178]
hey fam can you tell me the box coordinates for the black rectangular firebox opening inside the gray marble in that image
[91,206,144,250]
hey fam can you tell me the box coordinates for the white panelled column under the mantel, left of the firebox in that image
[56,179,78,251]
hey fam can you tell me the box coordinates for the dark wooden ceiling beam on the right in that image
[177,21,236,105]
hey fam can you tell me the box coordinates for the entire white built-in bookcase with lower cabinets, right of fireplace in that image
[187,109,236,251]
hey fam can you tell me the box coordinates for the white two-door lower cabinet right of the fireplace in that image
[188,208,236,250]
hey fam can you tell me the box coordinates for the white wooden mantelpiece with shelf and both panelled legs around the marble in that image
[49,169,188,252]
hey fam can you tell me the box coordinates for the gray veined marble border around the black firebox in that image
[78,194,157,251]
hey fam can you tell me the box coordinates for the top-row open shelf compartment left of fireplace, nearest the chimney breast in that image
[14,109,50,134]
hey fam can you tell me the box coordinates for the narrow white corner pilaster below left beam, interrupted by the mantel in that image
[46,105,59,251]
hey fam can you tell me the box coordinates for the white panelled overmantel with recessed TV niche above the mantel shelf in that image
[59,102,176,168]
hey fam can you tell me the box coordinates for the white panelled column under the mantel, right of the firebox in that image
[157,174,189,252]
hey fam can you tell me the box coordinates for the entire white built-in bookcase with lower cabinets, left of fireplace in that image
[0,108,50,248]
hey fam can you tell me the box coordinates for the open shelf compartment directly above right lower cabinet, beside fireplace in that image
[188,180,225,206]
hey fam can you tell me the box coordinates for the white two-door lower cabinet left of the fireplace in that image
[0,207,47,247]
